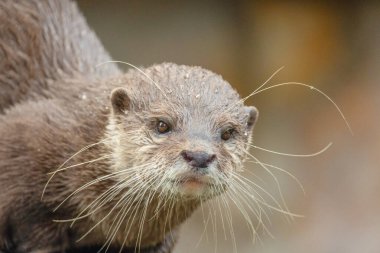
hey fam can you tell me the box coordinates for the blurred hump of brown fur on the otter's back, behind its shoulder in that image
[0,0,120,113]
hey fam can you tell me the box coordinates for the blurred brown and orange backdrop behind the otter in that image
[78,0,380,253]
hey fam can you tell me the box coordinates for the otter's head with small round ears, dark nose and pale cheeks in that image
[108,63,258,198]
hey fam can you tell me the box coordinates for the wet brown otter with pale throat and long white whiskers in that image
[0,0,258,253]
